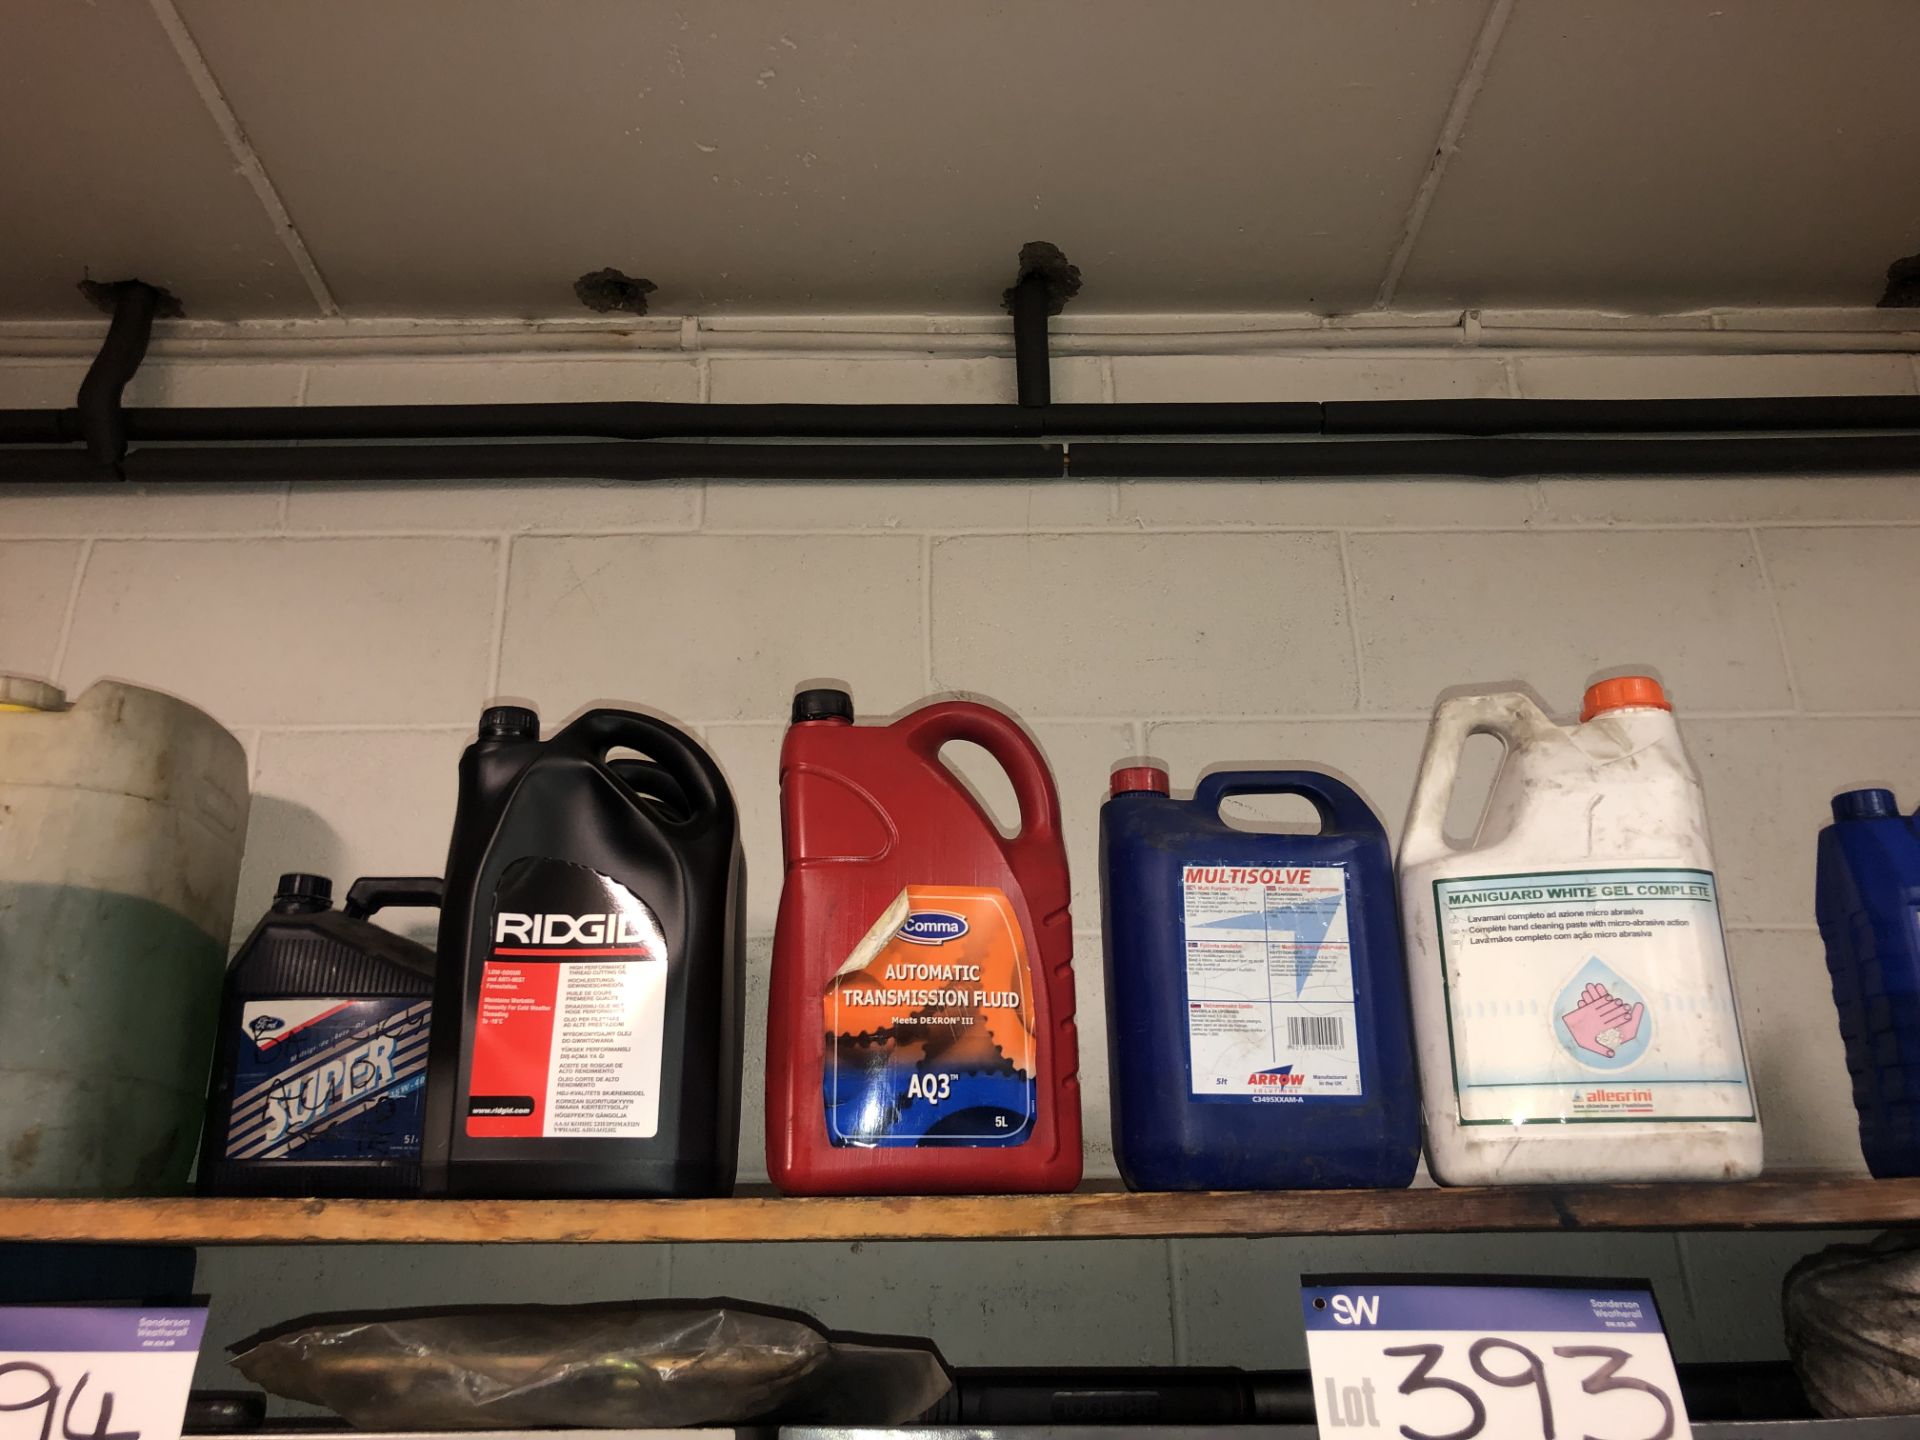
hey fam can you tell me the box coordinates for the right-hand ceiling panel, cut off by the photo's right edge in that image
[1396,0,1920,311]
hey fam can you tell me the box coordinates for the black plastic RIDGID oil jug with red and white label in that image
[424,707,745,1196]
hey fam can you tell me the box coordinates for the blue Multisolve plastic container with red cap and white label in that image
[1100,766,1421,1190]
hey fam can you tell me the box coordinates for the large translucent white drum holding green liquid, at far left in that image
[0,676,248,1194]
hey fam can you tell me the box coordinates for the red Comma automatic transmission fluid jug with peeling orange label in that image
[766,689,1081,1194]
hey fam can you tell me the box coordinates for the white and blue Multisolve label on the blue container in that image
[1181,864,1361,1104]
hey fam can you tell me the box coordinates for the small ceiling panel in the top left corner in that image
[0,0,313,319]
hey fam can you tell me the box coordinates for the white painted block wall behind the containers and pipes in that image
[0,336,1920,1382]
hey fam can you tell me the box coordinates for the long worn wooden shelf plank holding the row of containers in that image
[0,1179,1920,1244]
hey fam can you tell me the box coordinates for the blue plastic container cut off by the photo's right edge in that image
[1814,789,1920,1177]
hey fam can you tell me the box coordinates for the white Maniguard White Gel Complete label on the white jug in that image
[1434,870,1753,1125]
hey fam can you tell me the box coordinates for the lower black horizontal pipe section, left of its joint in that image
[0,440,1066,484]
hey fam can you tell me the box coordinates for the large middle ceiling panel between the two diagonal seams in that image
[168,0,1484,315]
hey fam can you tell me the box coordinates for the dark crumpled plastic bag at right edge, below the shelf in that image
[1784,1235,1920,1419]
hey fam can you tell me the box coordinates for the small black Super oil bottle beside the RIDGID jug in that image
[200,874,442,1196]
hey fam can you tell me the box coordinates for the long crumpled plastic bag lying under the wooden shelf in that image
[232,1304,952,1430]
